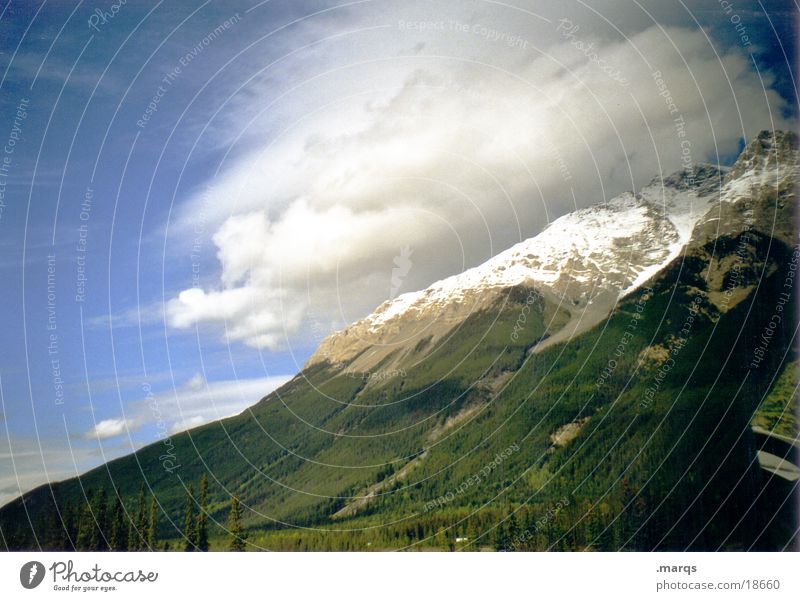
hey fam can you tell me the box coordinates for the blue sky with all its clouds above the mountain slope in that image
[0,0,798,504]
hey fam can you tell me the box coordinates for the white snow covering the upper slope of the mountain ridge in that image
[365,165,724,330]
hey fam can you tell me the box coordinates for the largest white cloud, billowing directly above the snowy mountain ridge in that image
[166,17,786,349]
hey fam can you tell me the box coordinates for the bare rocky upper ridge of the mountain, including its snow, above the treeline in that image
[306,132,797,372]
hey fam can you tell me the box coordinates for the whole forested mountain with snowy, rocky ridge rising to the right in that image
[0,132,798,550]
